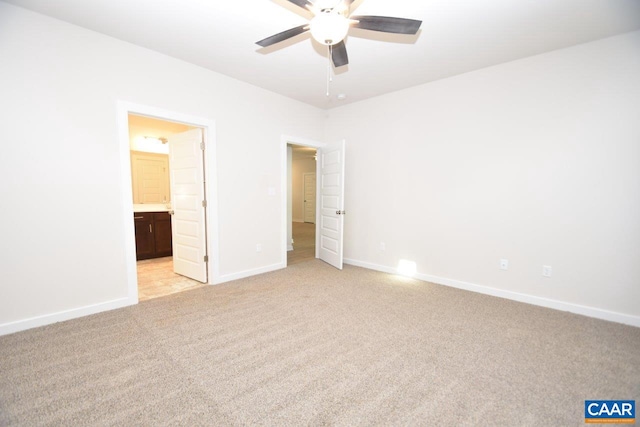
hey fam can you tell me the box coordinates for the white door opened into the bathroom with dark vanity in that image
[168,129,207,283]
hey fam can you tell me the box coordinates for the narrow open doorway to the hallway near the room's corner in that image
[287,144,317,265]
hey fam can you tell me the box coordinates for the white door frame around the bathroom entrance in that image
[116,101,220,304]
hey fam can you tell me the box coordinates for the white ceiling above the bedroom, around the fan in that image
[5,0,640,108]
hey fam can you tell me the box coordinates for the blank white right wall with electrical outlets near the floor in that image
[326,32,640,326]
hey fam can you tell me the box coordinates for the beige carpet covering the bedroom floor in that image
[0,260,640,426]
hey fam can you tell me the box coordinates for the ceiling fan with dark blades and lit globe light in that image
[256,0,422,67]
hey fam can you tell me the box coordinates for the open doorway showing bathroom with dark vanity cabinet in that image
[128,114,204,301]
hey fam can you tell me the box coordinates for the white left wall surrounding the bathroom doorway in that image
[0,2,324,333]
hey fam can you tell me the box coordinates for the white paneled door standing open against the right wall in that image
[318,140,345,270]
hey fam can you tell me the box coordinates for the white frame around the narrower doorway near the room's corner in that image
[280,135,325,268]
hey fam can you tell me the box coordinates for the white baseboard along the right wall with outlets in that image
[344,258,640,327]
